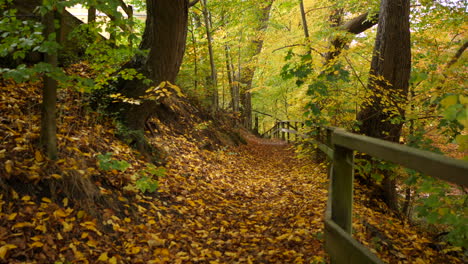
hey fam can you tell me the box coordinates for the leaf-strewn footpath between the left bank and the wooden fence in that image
[154,138,327,263]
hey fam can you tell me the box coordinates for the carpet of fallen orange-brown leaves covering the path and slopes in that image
[0,79,462,264]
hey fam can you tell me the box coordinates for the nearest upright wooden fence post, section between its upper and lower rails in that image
[331,145,354,234]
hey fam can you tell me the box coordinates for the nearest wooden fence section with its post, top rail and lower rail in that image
[264,122,468,264]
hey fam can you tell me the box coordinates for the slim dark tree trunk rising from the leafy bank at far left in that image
[40,7,60,159]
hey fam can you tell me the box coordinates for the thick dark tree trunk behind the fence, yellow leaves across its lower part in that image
[358,0,411,209]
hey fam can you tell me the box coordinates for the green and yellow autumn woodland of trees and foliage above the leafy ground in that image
[0,0,468,259]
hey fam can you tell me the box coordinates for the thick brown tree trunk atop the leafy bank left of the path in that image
[114,0,189,151]
